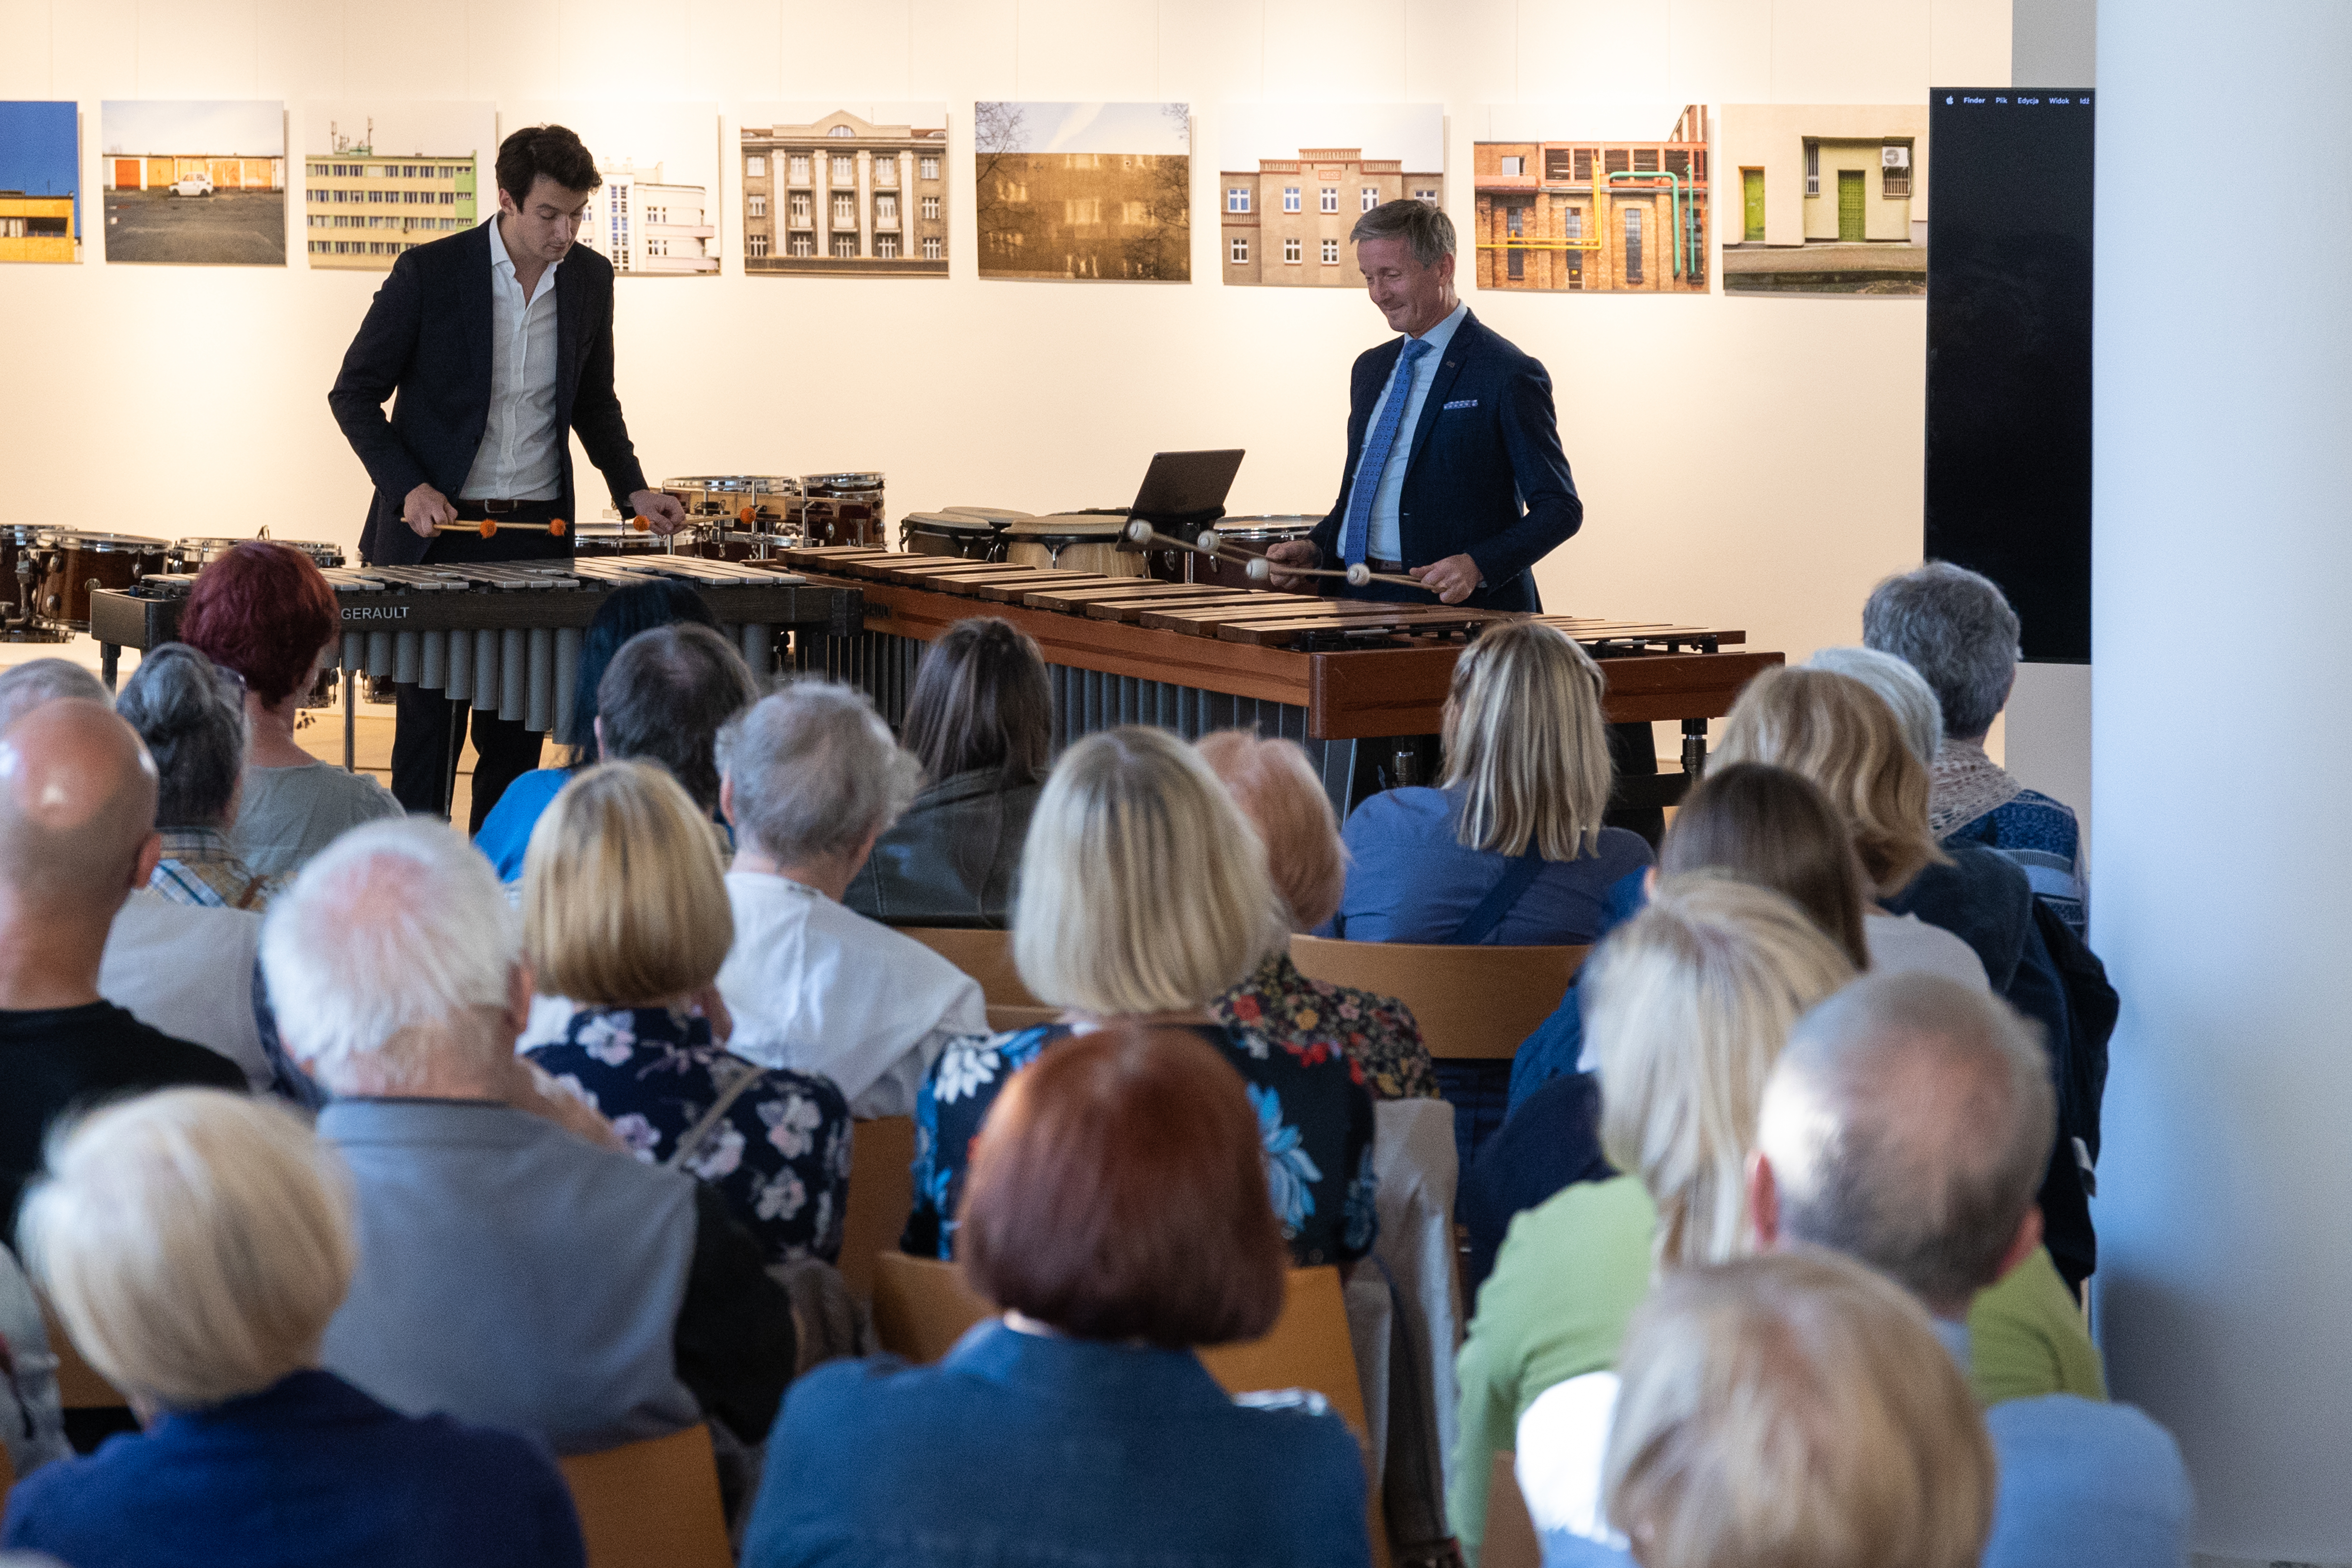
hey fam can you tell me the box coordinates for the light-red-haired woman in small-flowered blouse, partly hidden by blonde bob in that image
[1192,729,1439,1100]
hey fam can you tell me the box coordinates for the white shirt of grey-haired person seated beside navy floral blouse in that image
[720,872,988,1117]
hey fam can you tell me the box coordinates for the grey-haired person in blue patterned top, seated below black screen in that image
[1863,562,2089,936]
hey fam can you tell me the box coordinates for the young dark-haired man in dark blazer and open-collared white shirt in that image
[327,125,684,830]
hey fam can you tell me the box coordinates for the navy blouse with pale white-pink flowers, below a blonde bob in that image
[524,1006,849,1262]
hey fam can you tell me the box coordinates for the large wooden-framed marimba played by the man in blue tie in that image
[774,548,1780,811]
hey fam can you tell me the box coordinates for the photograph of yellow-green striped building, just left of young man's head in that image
[301,99,499,273]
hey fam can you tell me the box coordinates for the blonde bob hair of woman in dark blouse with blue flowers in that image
[1014,726,1287,1018]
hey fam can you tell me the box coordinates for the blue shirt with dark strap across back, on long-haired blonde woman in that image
[1331,788,1649,947]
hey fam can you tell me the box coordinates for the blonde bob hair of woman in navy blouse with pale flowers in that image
[522,762,734,1006]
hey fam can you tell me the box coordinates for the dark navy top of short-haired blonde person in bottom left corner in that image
[0,1370,586,1568]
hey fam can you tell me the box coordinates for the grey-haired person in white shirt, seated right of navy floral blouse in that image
[717,682,988,1117]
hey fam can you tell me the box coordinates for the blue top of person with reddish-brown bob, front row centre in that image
[743,1321,1371,1568]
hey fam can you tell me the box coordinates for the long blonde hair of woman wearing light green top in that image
[1583,872,1853,1269]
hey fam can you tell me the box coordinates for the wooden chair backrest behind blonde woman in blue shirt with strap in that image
[1291,936,1592,1060]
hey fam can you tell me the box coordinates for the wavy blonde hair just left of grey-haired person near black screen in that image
[1715,668,1950,898]
